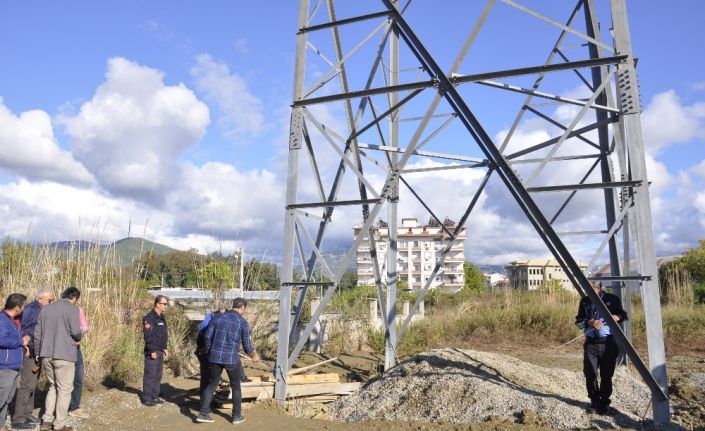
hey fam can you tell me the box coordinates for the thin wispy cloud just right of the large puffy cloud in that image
[191,54,265,143]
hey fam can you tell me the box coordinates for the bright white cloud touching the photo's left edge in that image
[0,98,94,185]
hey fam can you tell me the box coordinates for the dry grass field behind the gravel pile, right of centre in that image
[367,289,705,356]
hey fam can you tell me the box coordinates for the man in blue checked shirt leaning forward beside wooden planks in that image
[196,298,260,424]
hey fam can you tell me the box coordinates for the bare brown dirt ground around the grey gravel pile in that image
[16,345,705,431]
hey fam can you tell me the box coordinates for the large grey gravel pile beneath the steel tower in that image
[328,349,651,428]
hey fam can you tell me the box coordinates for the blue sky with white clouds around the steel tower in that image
[0,0,705,263]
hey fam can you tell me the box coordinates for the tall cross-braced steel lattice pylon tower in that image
[275,0,670,423]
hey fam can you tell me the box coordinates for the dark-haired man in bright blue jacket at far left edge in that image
[0,293,29,430]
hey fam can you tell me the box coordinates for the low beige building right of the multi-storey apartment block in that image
[504,259,587,291]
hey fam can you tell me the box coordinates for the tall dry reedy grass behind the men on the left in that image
[0,239,190,387]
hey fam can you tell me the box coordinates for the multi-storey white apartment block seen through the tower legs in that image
[353,218,467,289]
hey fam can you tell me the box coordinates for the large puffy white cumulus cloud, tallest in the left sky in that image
[60,58,209,201]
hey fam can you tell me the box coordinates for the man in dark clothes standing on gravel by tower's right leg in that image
[575,283,627,414]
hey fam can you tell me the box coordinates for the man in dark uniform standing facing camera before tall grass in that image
[142,295,169,407]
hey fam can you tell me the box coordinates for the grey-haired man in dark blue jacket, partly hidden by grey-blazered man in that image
[12,289,55,429]
